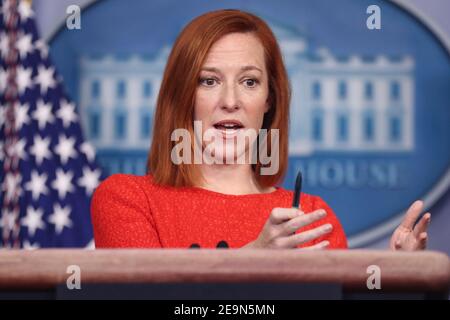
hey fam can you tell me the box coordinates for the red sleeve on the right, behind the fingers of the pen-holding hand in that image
[313,196,348,249]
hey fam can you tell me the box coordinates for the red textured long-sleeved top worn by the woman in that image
[91,174,347,249]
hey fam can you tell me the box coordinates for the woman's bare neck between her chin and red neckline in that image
[200,164,275,195]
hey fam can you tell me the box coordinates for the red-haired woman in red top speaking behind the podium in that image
[92,10,430,250]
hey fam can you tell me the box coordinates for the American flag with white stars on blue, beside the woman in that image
[0,0,103,249]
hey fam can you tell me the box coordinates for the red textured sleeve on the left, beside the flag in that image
[91,174,161,248]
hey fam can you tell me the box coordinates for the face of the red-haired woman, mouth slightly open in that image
[194,33,270,163]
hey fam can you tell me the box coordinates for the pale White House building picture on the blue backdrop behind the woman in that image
[79,25,414,174]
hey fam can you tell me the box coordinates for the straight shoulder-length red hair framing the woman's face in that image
[147,9,291,187]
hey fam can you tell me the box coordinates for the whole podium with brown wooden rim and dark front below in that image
[0,249,450,299]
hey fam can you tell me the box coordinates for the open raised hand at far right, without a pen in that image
[390,200,431,251]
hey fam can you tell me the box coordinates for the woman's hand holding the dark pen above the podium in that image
[243,208,333,250]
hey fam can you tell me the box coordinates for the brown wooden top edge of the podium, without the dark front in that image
[0,249,450,292]
